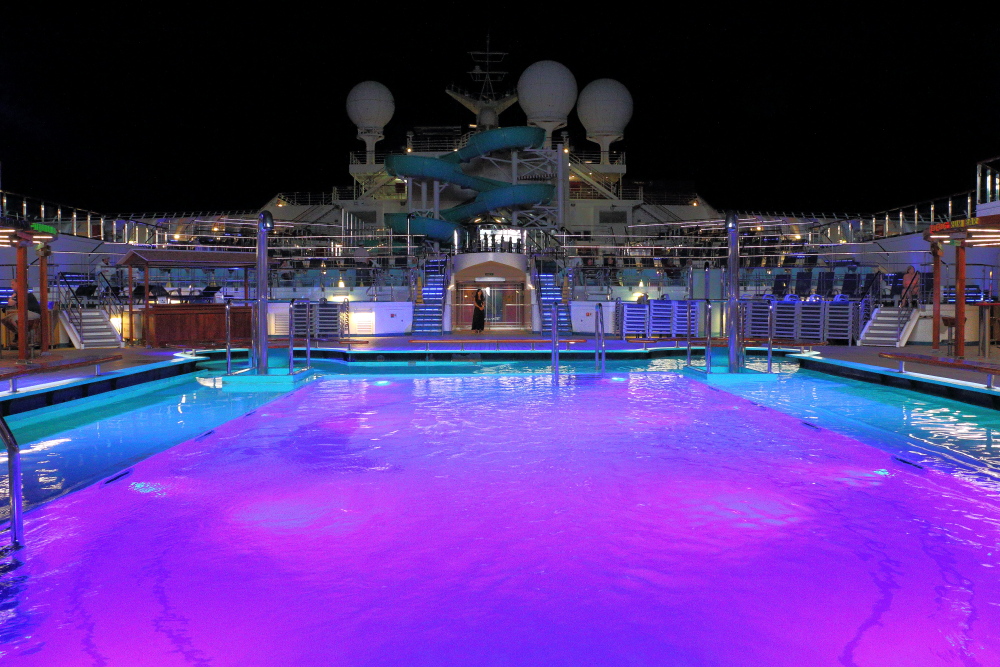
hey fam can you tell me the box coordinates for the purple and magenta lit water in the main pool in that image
[0,373,1000,667]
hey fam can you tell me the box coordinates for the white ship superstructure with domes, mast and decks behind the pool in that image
[0,46,1000,342]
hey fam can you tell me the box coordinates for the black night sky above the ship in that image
[0,2,1000,213]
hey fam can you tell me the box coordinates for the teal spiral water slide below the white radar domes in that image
[385,127,555,241]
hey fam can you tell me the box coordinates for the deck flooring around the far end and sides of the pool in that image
[0,332,1000,396]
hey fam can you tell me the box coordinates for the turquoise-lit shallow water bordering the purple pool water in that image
[0,355,1000,516]
